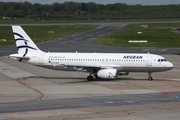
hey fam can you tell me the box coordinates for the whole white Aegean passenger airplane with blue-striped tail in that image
[9,25,174,81]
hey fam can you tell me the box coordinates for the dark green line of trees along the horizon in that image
[0,1,180,20]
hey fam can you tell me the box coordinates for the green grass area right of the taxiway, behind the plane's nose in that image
[94,23,180,48]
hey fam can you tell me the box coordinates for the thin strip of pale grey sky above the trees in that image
[0,0,180,5]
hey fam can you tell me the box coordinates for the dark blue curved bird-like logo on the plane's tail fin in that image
[14,32,37,57]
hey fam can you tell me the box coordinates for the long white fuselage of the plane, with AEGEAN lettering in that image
[27,52,173,72]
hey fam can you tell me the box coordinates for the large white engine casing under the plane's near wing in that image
[97,69,117,79]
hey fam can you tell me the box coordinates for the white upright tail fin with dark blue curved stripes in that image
[12,26,41,57]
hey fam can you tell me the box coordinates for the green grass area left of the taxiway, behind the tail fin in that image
[0,25,98,45]
